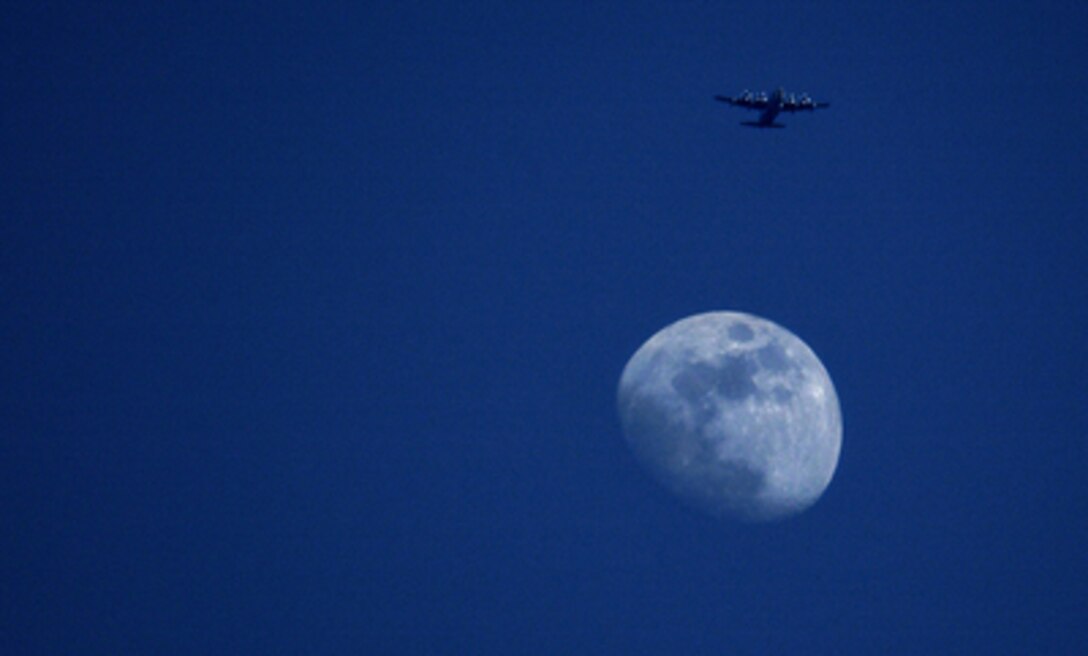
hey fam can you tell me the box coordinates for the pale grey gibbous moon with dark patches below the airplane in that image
[617,312,842,521]
